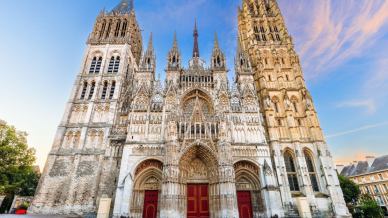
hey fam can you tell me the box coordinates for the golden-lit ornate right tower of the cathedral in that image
[238,0,348,216]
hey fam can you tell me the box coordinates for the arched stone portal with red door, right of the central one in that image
[234,161,264,218]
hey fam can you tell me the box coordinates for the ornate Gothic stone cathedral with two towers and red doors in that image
[29,0,350,218]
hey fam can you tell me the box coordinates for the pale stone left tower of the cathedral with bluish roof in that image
[29,0,142,215]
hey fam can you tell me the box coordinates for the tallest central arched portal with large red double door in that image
[179,145,219,218]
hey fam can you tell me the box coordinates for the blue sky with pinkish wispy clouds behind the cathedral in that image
[0,0,388,168]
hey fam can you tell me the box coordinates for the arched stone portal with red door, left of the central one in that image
[130,159,163,218]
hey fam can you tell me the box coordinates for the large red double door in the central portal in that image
[187,184,210,218]
